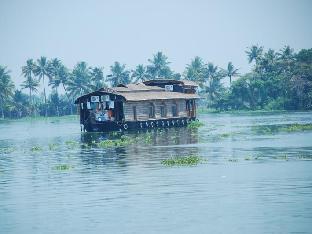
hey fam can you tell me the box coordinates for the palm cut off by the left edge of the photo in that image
[0,65,14,119]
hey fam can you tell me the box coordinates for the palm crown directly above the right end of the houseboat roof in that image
[184,56,204,82]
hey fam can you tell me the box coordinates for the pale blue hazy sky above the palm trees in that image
[0,0,312,85]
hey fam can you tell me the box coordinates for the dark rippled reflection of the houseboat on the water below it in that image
[81,127,199,167]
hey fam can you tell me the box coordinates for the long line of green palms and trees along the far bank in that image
[0,45,312,118]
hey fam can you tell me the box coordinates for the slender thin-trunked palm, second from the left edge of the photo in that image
[21,59,39,113]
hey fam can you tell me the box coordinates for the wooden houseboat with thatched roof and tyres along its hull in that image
[75,79,199,132]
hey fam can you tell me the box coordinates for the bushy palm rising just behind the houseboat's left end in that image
[67,62,91,98]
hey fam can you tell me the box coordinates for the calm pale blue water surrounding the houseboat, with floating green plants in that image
[0,113,312,233]
